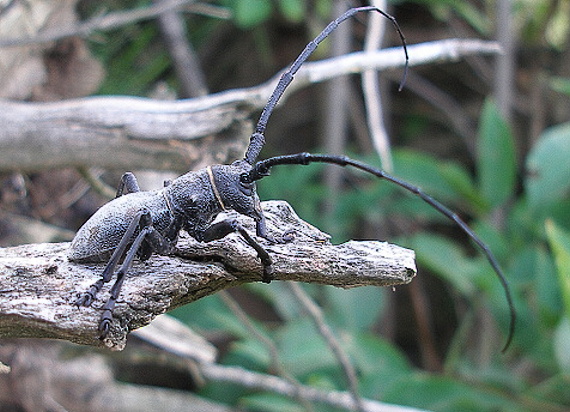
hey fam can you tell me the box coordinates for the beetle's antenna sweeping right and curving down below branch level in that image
[241,153,516,352]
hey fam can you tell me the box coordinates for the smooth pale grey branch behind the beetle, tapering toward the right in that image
[0,39,500,171]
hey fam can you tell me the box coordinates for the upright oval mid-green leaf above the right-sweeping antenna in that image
[477,100,516,208]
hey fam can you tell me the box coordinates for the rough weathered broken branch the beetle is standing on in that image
[0,201,416,349]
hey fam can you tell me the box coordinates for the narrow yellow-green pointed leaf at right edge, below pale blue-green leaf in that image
[546,220,570,319]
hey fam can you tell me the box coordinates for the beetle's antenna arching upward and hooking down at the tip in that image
[244,6,408,165]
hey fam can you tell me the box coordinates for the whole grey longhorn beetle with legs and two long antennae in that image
[68,6,516,351]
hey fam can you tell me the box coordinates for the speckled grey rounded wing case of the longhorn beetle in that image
[67,189,170,262]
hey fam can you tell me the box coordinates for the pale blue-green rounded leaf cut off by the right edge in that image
[525,123,570,210]
